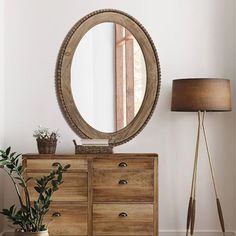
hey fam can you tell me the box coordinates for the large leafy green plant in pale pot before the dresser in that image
[0,147,70,236]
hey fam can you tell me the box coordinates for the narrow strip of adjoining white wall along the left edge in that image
[0,0,5,234]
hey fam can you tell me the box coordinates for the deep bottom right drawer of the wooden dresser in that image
[93,204,153,235]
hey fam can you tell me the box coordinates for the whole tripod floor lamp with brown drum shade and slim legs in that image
[171,78,232,235]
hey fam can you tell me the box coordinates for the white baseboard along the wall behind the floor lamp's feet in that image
[159,231,236,236]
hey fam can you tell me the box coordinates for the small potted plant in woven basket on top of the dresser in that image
[33,126,60,154]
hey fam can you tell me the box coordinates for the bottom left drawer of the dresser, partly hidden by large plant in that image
[45,204,87,236]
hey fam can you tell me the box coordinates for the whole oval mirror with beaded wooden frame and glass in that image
[56,10,160,146]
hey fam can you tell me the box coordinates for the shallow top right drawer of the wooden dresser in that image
[93,157,154,171]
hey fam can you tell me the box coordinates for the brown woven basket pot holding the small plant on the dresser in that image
[36,138,57,154]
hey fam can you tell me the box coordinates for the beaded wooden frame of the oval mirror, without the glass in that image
[55,9,160,146]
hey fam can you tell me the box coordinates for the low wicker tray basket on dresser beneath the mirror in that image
[73,140,113,154]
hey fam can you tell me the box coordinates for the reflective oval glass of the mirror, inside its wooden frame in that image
[71,23,146,132]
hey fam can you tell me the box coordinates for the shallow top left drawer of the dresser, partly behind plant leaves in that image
[26,159,88,172]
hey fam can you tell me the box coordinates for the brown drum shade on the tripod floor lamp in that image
[171,78,232,111]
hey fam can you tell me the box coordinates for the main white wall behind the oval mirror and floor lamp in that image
[1,0,236,231]
